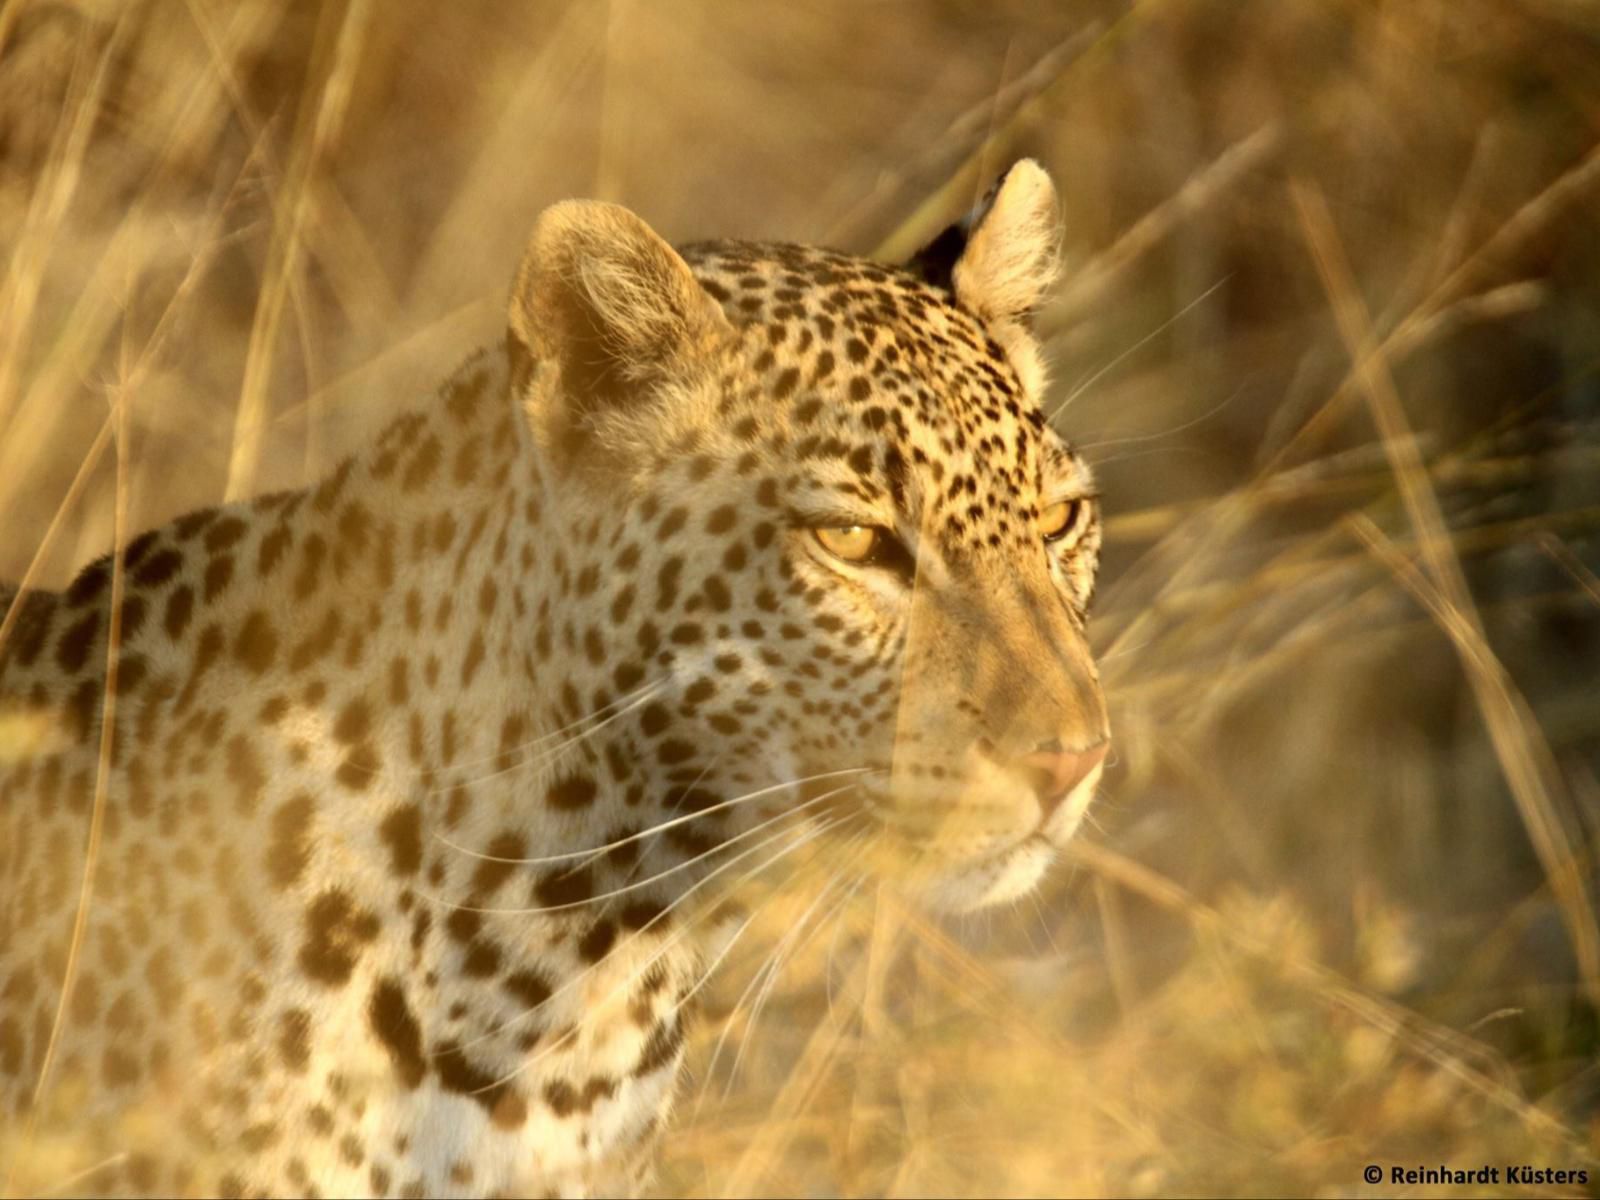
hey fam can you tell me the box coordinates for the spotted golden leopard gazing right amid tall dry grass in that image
[0,158,1110,1197]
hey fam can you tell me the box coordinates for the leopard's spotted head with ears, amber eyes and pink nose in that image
[523,163,1107,909]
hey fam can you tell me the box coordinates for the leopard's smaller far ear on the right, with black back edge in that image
[907,158,1061,323]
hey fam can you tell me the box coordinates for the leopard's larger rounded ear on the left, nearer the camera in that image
[509,200,730,451]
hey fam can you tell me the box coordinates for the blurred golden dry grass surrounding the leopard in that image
[0,0,1600,1195]
